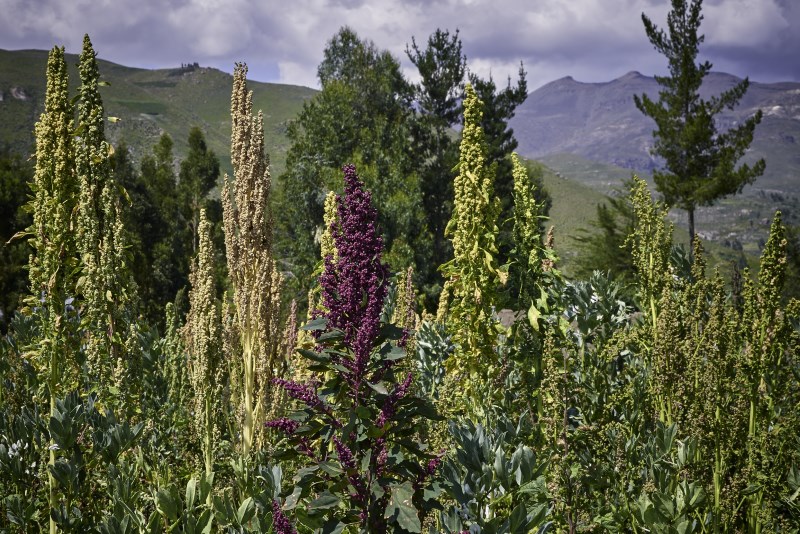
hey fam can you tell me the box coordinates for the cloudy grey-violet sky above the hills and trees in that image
[0,0,800,90]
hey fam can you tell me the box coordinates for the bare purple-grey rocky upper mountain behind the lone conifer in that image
[511,72,800,193]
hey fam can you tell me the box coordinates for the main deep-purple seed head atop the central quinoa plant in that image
[319,165,389,389]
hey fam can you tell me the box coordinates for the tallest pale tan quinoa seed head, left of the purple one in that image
[222,64,282,458]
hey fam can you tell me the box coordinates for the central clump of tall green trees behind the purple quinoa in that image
[277,27,527,312]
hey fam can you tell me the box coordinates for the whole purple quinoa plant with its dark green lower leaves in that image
[267,165,441,532]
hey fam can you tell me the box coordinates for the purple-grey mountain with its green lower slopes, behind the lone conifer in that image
[511,72,800,258]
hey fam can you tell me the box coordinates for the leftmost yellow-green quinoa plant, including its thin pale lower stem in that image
[28,47,81,534]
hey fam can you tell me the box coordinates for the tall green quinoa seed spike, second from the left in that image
[75,35,139,402]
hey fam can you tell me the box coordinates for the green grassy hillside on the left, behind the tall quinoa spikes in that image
[0,50,316,173]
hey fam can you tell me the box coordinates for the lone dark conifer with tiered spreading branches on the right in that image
[634,0,765,246]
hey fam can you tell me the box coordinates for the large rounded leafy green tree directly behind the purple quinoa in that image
[277,27,434,308]
